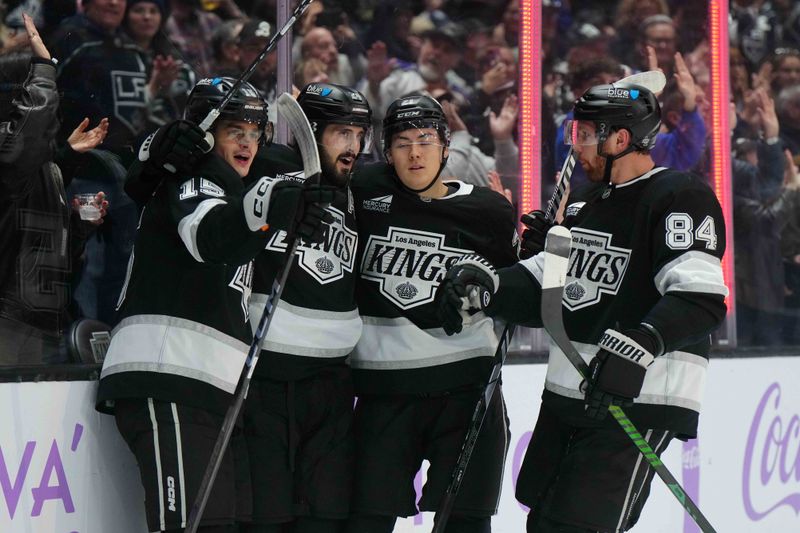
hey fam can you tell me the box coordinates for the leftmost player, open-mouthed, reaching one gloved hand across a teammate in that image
[97,78,333,533]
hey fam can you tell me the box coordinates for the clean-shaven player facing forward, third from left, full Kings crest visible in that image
[347,95,517,533]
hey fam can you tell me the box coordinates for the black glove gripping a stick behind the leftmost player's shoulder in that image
[139,120,214,174]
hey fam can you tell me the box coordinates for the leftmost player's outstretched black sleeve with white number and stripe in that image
[165,170,266,265]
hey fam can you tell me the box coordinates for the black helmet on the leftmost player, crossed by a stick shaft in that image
[183,77,273,144]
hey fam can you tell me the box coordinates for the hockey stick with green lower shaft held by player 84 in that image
[541,226,716,533]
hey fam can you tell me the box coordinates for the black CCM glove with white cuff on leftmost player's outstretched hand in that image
[243,177,338,242]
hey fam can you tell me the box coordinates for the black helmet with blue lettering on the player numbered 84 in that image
[564,82,661,152]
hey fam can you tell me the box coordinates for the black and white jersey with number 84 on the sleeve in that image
[520,168,728,436]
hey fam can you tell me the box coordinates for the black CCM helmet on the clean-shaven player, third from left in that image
[383,94,450,153]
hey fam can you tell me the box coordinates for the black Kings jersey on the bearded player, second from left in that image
[242,145,361,381]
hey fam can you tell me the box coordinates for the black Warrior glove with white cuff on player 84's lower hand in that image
[586,329,661,420]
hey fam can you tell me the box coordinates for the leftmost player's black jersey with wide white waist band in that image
[97,154,266,413]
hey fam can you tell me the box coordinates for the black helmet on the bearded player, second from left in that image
[297,83,372,152]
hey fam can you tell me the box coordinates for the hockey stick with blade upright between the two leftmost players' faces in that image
[185,91,322,533]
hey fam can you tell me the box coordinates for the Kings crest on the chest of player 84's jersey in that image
[563,228,631,311]
